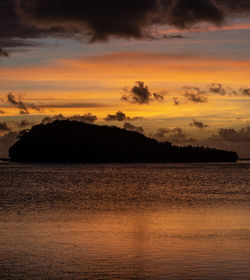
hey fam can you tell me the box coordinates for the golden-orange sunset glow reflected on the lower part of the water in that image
[1,208,250,279]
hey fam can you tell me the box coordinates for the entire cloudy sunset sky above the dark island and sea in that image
[0,0,250,157]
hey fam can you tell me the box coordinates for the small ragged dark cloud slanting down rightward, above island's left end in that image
[7,93,41,115]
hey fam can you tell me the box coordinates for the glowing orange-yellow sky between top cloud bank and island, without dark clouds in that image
[0,22,250,158]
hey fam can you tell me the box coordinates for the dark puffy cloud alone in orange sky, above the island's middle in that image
[121,81,166,104]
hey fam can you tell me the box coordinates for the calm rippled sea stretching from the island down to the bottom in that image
[0,162,250,280]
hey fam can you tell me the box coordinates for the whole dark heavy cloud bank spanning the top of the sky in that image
[0,0,250,54]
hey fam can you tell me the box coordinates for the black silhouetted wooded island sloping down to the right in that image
[9,120,238,163]
